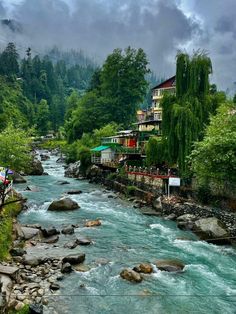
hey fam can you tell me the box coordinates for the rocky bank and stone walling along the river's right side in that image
[65,163,236,245]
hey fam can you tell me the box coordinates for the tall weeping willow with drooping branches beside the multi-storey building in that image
[162,51,212,175]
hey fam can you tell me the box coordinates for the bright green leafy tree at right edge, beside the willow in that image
[191,102,236,184]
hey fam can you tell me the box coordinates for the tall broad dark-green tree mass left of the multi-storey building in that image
[66,47,149,141]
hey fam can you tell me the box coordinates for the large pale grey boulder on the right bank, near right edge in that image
[193,217,229,244]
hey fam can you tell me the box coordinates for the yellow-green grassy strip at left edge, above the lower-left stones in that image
[0,197,21,261]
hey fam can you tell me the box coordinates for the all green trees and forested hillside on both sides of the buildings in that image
[0,43,236,195]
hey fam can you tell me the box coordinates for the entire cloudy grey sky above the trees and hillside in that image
[0,0,236,89]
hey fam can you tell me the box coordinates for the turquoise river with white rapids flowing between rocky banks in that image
[17,151,236,314]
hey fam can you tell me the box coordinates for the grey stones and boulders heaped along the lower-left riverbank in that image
[0,216,97,314]
